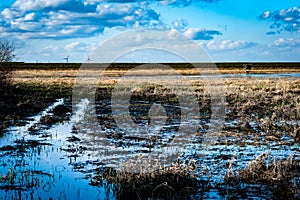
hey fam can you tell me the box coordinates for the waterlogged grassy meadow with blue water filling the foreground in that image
[0,66,300,199]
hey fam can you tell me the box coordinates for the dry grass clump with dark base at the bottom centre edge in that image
[91,155,200,199]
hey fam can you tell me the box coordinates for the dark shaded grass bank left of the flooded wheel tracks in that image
[0,82,72,133]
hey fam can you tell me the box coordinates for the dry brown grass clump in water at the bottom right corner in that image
[224,153,300,197]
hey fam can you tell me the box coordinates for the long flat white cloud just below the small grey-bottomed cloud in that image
[205,40,257,50]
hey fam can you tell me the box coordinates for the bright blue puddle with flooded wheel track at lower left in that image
[0,99,114,199]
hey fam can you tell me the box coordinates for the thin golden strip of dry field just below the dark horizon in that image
[12,68,300,84]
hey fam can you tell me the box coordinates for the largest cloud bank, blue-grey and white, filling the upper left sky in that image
[0,0,163,39]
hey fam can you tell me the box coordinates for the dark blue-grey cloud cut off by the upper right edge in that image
[259,7,300,33]
